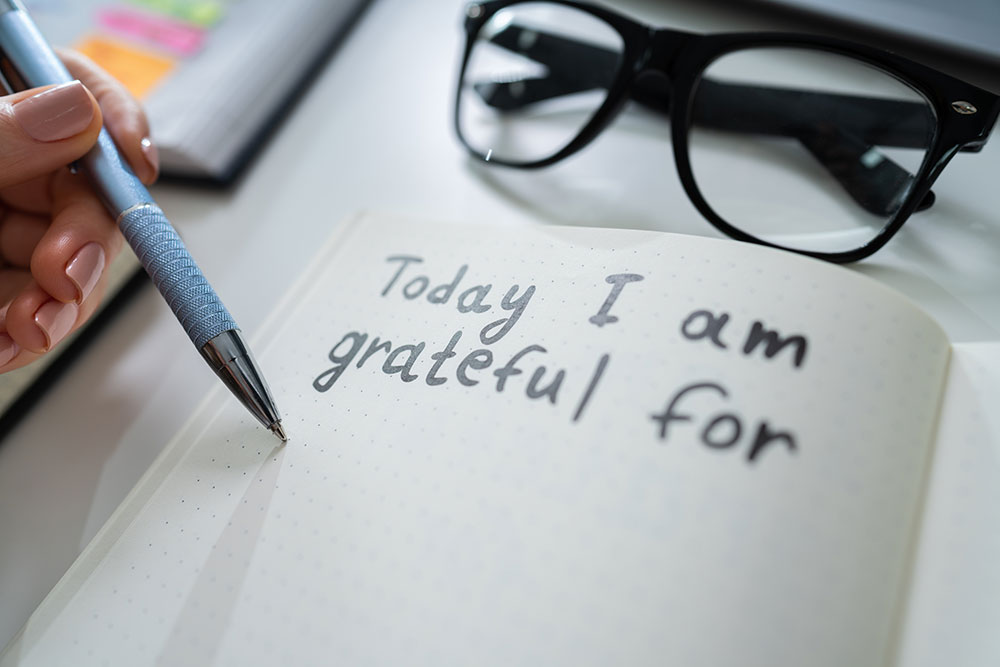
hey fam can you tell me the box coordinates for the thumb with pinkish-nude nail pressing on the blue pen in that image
[0,81,101,188]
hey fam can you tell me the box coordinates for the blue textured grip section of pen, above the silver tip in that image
[118,204,237,349]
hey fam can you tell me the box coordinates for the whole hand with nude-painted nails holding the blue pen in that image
[0,51,158,373]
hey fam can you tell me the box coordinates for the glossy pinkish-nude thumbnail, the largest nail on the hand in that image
[13,81,94,141]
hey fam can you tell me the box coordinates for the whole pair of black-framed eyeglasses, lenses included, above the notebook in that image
[455,0,1000,262]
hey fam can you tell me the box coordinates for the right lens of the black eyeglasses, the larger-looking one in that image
[688,47,935,252]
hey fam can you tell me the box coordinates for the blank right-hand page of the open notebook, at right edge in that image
[899,342,1000,667]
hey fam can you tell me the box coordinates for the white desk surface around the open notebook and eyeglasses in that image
[0,0,1000,646]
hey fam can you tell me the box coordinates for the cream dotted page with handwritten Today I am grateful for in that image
[0,215,949,667]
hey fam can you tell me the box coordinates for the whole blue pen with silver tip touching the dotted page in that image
[0,0,288,442]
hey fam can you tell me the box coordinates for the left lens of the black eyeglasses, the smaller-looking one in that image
[458,2,624,164]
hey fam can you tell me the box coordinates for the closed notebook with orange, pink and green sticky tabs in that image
[25,0,367,182]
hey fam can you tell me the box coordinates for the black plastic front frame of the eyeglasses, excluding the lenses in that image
[454,0,1000,263]
